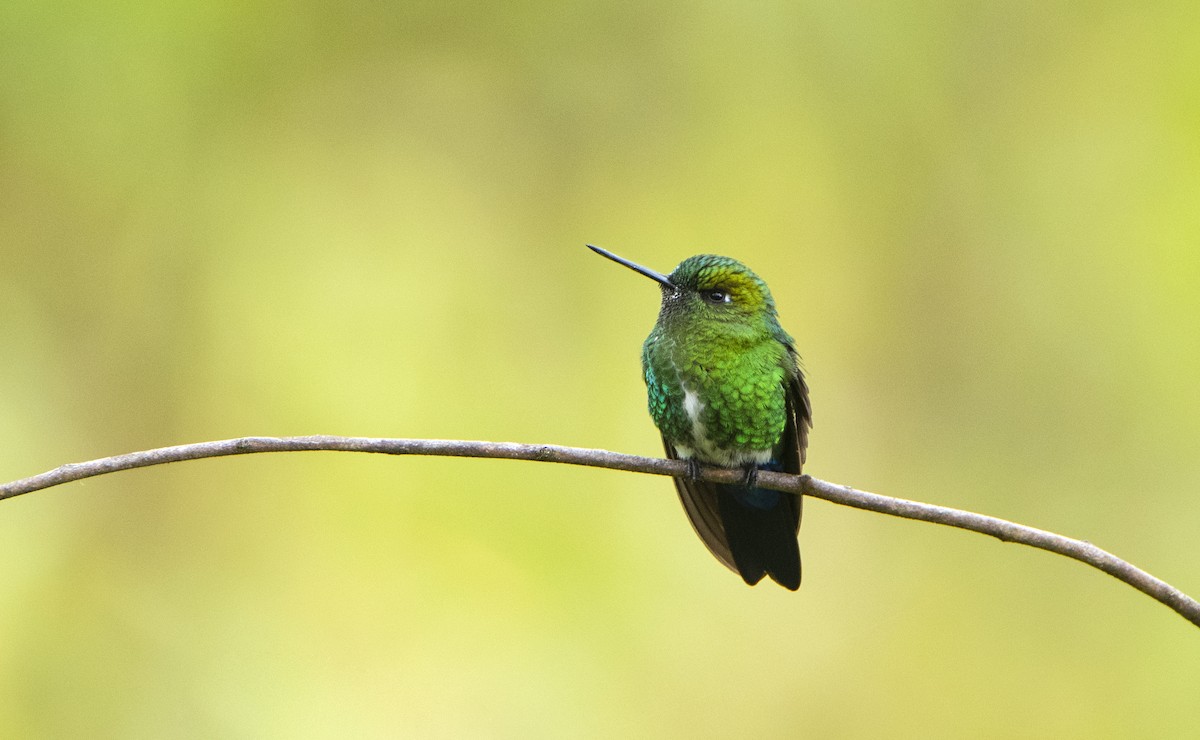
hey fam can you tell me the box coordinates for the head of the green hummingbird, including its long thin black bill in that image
[588,245,778,329]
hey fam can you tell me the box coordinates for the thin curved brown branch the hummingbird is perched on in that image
[0,435,1200,626]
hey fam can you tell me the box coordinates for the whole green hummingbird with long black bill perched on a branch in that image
[587,245,812,591]
